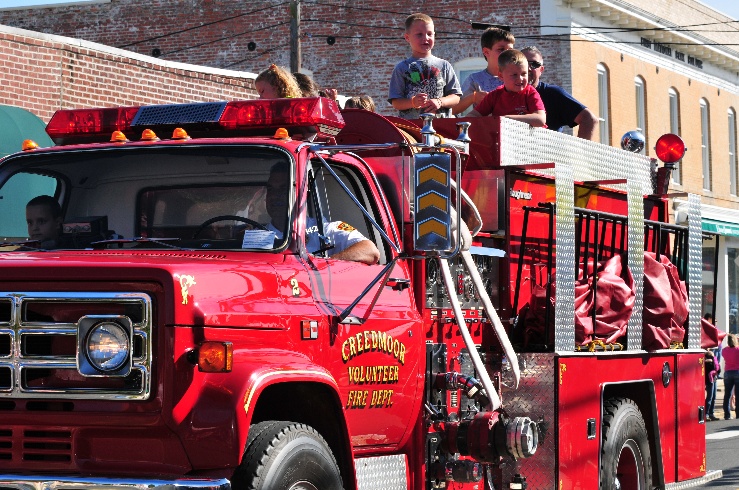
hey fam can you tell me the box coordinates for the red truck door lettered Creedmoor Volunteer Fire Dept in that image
[306,165,423,446]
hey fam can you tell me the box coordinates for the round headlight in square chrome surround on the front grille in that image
[85,322,131,373]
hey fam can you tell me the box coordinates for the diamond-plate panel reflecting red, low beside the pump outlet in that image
[497,353,558,490]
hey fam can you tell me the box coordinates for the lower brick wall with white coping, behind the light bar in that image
[0,26,256,121]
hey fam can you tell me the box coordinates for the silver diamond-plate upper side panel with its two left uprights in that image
[500,118,652,351]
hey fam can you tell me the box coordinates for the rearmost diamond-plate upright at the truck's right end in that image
[686,194,703,349]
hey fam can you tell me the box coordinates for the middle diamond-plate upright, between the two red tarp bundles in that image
[626,180,644,350]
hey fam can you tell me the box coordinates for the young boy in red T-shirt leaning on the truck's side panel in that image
[469,49,547,128]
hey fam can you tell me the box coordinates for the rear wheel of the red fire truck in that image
[600,398,652,490]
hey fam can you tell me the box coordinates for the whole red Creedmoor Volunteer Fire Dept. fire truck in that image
[0,98,720,490]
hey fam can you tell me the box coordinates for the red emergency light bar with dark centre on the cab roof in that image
[46,97,344,145]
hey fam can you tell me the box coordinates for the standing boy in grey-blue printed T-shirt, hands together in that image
[388,13,462,119]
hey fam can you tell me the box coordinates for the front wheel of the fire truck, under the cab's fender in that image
[231,420,344,490]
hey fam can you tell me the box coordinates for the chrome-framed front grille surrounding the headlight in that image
[0,292,152,400]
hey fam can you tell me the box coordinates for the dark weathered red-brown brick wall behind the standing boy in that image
[0,0,569,113]
